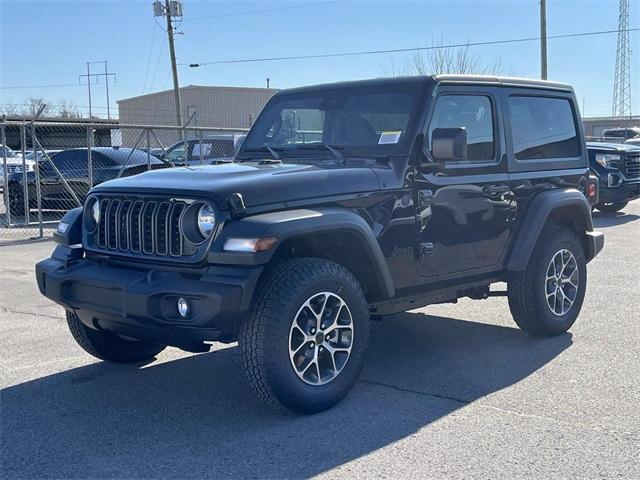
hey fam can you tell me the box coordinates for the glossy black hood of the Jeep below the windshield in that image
[93,163,380,208]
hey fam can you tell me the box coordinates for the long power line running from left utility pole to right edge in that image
[189,28,640,67]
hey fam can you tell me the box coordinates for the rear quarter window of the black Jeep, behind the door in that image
[509,97,580,160]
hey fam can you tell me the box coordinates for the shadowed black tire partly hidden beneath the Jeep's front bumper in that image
[67,312,166,363]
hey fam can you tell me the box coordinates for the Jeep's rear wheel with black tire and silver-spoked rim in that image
[508,224,587,337]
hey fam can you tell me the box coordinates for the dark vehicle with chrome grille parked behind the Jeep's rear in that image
[587,142,640,213]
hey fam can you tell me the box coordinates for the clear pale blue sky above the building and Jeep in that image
[0,0,640,116]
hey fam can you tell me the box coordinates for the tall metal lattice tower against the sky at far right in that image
[611,0,631,117]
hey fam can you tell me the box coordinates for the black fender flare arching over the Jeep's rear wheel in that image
[507,188,602,272]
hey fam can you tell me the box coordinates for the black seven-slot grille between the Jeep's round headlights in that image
[93,197,197,257]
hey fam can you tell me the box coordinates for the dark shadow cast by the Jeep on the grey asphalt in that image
[0,313,571,478]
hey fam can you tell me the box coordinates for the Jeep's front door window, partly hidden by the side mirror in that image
[429,95,496,161]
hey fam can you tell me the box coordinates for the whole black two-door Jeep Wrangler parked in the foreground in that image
[36,76,604,413]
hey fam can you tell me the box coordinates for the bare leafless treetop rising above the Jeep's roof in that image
[383,44,511,76]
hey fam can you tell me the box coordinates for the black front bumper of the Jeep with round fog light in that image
[36,245,262,351]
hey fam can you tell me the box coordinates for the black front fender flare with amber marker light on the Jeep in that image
[208,207,395,298]
